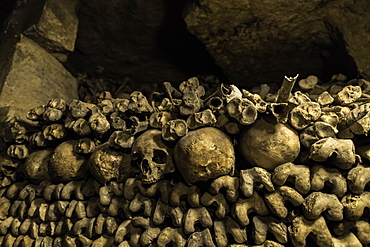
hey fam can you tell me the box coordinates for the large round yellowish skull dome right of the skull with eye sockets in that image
[174,127,235,183]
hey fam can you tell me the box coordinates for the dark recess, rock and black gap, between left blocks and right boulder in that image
[67,0,220,83]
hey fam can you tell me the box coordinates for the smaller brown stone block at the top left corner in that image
[25,0,78,60]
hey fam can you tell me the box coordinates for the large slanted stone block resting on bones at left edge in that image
[0,35,78,123]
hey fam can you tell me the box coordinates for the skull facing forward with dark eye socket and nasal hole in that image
[132,129,175,184]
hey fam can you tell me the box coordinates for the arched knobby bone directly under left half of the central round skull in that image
[169,182,200,207]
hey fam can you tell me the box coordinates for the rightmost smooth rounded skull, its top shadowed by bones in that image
[239,118,300,171]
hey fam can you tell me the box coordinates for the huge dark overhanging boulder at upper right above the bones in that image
[184,0,370,85]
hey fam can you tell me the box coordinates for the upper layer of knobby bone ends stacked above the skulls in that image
[3,75,370,155]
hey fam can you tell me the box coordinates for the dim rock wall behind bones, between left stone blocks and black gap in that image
[65,0,188,83]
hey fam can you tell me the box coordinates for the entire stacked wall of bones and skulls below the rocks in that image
[0,75,370,247]
